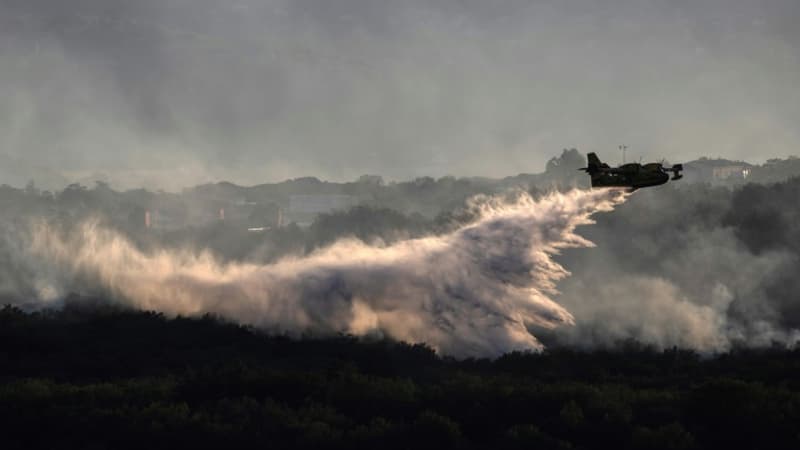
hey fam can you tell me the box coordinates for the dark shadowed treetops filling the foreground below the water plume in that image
[0,301,800,449]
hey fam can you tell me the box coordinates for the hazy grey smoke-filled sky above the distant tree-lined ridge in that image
[0,0,800,189]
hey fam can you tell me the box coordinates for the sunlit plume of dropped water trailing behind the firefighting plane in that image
[23,190,626,356]
